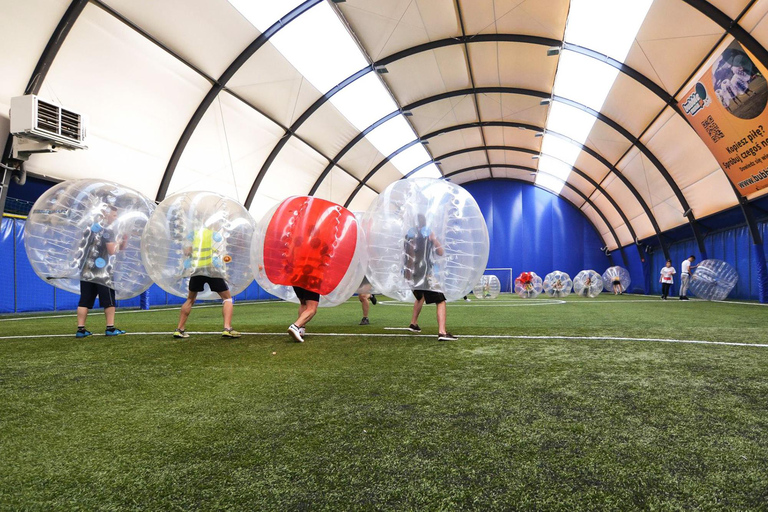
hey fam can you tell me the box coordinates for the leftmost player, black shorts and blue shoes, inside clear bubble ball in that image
[75,204,126,338]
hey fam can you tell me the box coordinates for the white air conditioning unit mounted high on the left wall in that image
[11,94,88,151]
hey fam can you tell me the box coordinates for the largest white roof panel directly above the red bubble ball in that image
[258,137,328,200]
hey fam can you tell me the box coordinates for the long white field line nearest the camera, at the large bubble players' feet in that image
[0,331,768,348]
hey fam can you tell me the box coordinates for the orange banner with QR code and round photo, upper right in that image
[679,38,768,196]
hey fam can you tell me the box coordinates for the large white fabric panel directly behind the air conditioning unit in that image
[28,4,210,198]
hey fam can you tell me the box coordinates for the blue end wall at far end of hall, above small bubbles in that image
[462,180,608,279]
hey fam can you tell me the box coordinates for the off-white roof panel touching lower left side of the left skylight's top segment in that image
[227,43,322,127]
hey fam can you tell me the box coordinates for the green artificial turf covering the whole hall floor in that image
[0,294,768,510]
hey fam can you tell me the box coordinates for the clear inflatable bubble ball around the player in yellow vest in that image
[141,191,254,300]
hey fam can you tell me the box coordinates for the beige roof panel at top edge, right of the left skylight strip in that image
[338,0,461,60]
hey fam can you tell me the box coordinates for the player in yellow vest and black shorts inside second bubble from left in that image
[173,217,240,338]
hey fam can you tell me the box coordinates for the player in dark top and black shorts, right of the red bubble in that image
[403,213,458,341]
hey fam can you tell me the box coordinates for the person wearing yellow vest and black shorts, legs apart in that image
[173,227,240,338]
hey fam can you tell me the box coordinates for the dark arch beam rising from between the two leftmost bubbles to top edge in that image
[155,0,323,203]
